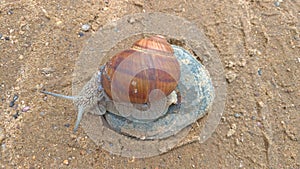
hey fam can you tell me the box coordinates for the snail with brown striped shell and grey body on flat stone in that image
[41,35,180,132]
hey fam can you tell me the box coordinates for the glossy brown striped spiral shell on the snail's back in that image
[101,35,180,103]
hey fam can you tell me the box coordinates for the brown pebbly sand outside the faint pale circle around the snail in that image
[0,0,300,169]
